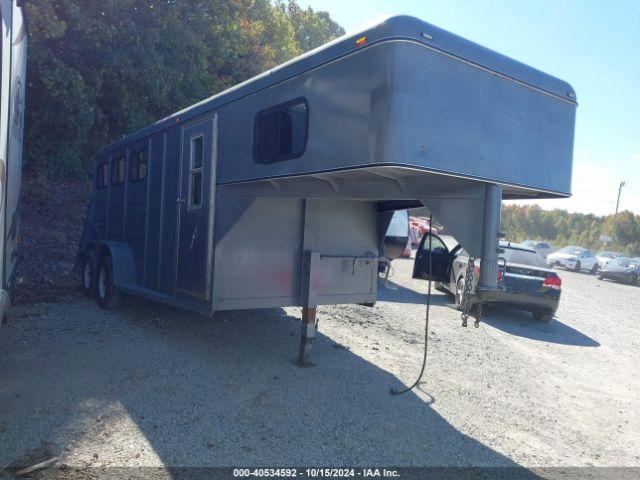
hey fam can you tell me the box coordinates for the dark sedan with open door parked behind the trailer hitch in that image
[413,235,562,322]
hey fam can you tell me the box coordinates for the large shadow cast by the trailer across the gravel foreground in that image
[0,300,538,478]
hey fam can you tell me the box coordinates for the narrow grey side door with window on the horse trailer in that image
[176,114,218,300]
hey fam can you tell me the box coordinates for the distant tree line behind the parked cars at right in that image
[502,205,640,256]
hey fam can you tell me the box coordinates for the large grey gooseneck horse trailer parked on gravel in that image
[80,16,576,366]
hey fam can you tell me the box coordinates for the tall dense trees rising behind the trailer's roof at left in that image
[24,0,343,175]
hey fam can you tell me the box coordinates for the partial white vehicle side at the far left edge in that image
[0,0,27,323]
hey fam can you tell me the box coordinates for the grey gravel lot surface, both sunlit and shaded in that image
[0,259,640,468]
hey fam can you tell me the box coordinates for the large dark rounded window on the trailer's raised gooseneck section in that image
[253,99,309,163]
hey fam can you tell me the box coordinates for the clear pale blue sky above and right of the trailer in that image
[298,0,640,215]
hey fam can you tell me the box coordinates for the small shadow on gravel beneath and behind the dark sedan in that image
[482,307,600,347]
